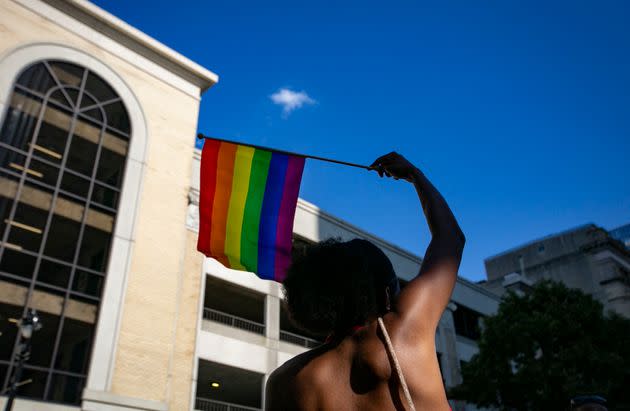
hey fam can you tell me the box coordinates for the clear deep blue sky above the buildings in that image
[95,0,630,281]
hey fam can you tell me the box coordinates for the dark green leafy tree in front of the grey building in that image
[449,281,630,410]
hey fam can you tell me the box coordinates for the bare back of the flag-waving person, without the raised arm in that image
[266,313,449,410]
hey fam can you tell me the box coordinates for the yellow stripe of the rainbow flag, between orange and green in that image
[225,146,255,270]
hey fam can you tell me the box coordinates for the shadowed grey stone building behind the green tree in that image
[481,224,630,318]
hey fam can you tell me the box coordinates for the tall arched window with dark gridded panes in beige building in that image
[0,60,131,404]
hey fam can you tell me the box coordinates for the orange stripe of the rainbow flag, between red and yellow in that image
[210,142,238,267]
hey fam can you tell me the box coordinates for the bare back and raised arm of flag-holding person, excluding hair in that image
[266,153,466,411]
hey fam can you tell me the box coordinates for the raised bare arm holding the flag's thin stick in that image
[371,153,466,339]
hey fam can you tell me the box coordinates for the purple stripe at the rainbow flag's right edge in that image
[274,156,304,282]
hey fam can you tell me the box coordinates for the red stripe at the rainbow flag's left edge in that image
[197,139,221,256]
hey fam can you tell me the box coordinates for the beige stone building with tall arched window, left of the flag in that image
[0,0,218,410]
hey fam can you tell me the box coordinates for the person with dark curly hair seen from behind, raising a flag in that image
[265,153,465,411]
